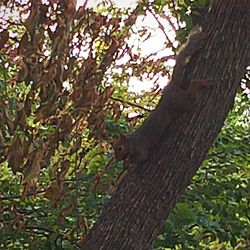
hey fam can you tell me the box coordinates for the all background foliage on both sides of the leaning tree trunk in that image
[0,0,250,249]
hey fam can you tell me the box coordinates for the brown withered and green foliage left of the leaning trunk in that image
[0,0,175,249]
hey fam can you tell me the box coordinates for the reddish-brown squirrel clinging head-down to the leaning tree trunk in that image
[113,26,213,169]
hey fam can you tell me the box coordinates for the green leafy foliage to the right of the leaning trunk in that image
[156,94,250,249]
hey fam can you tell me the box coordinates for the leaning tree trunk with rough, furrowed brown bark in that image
[84,0,250,250]
